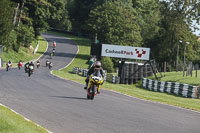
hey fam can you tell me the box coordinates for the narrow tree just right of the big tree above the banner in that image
[133,0,161,46]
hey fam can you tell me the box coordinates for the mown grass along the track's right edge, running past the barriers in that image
[51,32,200,111]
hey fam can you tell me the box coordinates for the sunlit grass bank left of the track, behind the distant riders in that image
[2,37,47,63]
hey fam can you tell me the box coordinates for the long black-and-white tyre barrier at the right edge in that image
[142,78,200,99]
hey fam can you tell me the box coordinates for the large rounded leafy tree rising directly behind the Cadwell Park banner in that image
[88,1,142,46]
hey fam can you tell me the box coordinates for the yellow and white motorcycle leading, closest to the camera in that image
[87,71,104,100]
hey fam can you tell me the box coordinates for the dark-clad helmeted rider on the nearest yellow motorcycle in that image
[84,61,104,93]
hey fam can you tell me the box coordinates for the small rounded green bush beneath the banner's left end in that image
[101,57,114,73]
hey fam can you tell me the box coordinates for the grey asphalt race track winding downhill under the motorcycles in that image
[0,34,200,133]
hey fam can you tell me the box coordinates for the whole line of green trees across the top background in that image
[0,0,200,66]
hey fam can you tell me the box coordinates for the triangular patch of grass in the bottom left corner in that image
[0,106,47,133]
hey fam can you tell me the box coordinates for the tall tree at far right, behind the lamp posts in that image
[143,0,199,63]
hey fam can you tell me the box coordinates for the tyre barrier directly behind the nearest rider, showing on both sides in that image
[72,67,120,84]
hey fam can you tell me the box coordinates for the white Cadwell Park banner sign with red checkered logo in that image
[101,44,150,60]
